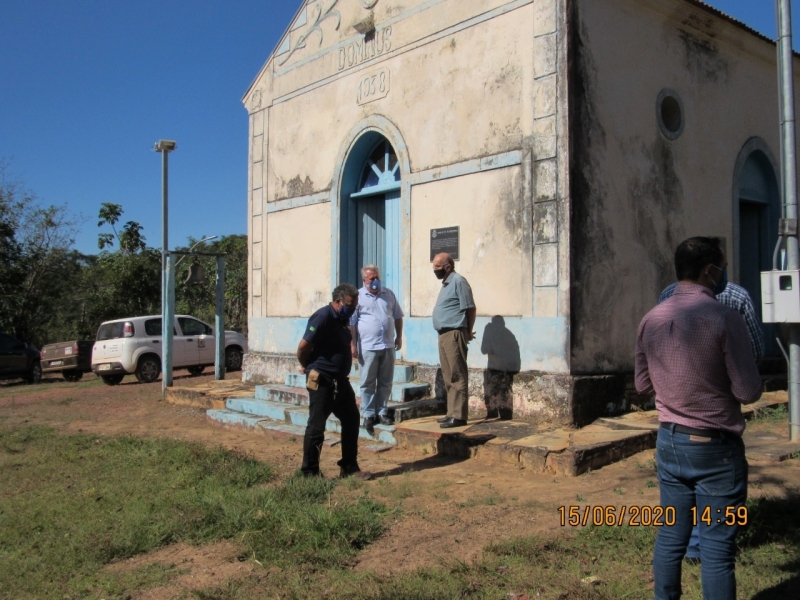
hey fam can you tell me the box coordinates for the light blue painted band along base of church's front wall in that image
[249,317,569,373]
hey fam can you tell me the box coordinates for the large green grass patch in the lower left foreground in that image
[0,427,384,599]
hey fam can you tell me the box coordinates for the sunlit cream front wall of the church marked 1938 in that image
[244,0,573,421]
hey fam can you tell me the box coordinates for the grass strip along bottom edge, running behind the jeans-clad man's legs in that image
[192,497,800,600]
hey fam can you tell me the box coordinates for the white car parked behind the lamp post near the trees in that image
[92,315,247,385]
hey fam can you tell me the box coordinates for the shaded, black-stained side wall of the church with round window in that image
[570,0,792,373]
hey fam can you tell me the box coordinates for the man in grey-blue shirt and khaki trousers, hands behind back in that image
[433,252,476,429]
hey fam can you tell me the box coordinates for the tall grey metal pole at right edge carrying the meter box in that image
[776,0,800,441]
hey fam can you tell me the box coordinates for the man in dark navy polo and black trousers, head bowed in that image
[297,283,371,479]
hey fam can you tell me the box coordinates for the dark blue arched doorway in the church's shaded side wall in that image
[734,139,781,356]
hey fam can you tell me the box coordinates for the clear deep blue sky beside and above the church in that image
[0,0,800,253]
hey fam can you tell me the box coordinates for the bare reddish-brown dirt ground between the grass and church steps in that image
[0,369,800,599]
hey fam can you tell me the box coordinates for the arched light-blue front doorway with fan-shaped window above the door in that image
[339,131,401,298]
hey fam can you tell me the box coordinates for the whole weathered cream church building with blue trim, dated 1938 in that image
[243,0,792,425]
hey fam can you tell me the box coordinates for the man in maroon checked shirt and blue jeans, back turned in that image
[636,237,762,600]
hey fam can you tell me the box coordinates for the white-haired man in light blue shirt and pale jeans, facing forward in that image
[350,264,403,433]
